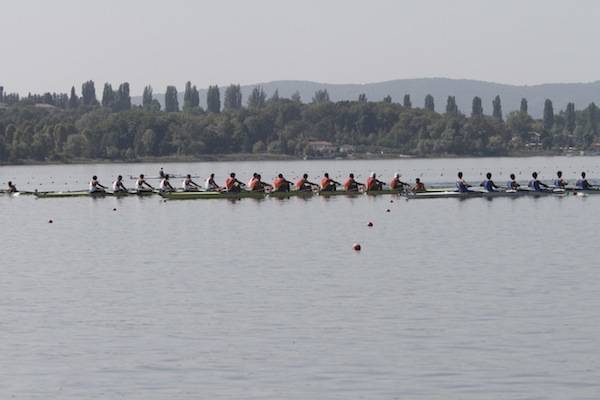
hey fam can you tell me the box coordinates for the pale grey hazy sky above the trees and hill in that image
[0,0,600,94]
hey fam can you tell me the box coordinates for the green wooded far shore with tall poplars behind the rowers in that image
[0,81,600,163]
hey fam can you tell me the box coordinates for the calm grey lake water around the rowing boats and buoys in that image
[0,157,600,400]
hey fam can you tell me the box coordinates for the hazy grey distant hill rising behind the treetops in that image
[132,78,600,117]
